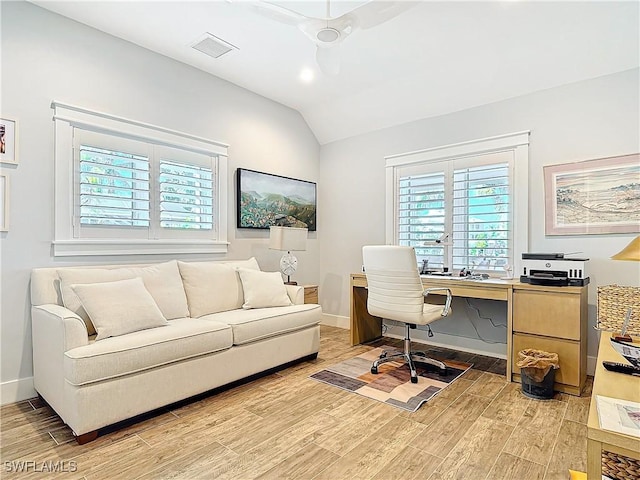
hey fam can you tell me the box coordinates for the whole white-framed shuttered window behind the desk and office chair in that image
[387,134,528,275]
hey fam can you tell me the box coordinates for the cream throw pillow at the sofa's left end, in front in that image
[71,278,169,341]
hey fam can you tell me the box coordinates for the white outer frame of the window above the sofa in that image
[51,101,229,257]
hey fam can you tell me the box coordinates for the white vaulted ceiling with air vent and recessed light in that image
[33,0,640,144]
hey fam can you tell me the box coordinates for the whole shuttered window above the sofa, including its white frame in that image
[54,100,227,256]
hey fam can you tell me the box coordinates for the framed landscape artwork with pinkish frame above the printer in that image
[543,153,640,235]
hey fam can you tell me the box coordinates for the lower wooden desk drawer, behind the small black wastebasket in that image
[512,333,580,387]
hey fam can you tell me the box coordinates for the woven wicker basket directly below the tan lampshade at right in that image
[597,285,640,335]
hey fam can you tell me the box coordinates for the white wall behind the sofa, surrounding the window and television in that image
[0,2,322,403]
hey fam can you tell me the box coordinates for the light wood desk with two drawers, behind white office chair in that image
[350,273,588,395]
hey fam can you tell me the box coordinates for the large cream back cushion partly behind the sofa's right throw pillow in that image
[178,261,244,318]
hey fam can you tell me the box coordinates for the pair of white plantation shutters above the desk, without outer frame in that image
[396,151,513,272]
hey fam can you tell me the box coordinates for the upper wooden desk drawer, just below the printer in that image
[513,290,581,340]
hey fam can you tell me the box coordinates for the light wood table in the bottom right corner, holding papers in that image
[587,332,640,479]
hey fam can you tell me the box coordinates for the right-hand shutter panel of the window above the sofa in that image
[159,161,214,230]
